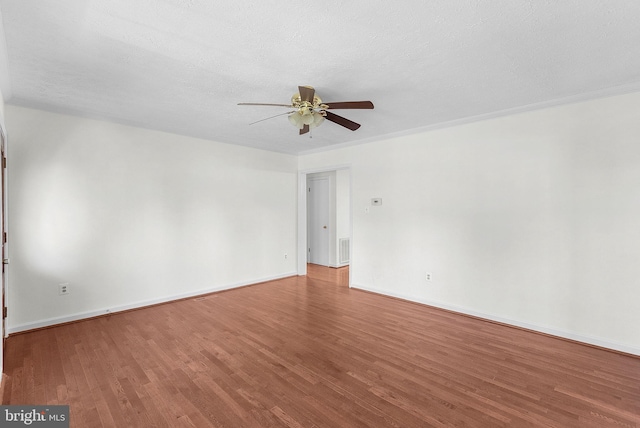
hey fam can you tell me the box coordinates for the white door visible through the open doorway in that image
[307,178,330,266]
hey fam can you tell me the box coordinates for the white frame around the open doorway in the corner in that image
[297,164,354,287]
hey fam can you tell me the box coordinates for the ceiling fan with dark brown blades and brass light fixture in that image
[238,86,373,135]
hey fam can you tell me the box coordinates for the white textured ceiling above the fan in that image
[0,0,640,154]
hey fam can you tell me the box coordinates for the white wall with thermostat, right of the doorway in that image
[299,93,640,354]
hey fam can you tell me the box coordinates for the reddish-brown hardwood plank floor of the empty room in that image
[2,267,640,428]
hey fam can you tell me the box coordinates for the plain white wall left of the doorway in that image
[6,106,297,333]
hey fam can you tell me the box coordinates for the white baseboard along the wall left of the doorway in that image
[6,272,297,334]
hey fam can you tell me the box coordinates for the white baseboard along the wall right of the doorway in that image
[351,284,640,356]
